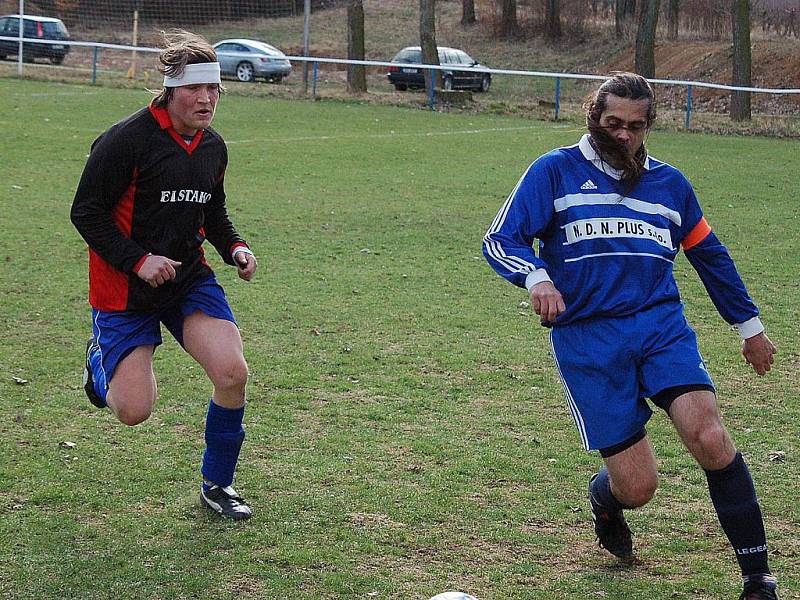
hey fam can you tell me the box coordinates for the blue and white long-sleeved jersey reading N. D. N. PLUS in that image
[483,135,763,337]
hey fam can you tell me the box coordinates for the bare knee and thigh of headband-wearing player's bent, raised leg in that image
[108,345,157,425]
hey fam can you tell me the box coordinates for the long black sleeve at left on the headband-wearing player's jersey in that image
[70,129,147,272]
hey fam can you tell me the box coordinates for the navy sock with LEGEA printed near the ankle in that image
[706,452,770,576]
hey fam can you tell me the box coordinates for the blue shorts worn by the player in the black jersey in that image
[92,274,236,392]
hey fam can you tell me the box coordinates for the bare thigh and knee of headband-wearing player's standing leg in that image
[183,310,247,388]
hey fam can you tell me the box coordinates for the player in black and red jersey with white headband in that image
[71,31,256,520]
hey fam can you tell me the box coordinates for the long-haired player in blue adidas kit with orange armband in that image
[483,73,778,600]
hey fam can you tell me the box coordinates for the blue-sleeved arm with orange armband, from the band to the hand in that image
[681,217,777,375]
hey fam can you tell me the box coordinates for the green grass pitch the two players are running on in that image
[0,79,800,600]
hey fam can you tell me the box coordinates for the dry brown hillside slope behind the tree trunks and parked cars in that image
[244,0,800,114]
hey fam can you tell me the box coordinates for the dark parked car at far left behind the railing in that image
[0,15,69,65]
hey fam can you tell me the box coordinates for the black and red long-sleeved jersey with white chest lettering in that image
[71,105,246,311]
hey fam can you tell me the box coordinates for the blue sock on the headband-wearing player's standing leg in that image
[201,400,244,490]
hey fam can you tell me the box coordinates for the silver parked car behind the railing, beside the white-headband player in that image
[214,39,292,83]
